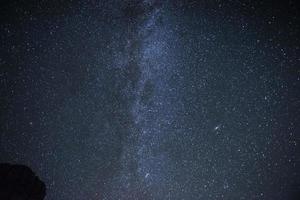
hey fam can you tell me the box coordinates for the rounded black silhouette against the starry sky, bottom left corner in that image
[0,163,46,200]
